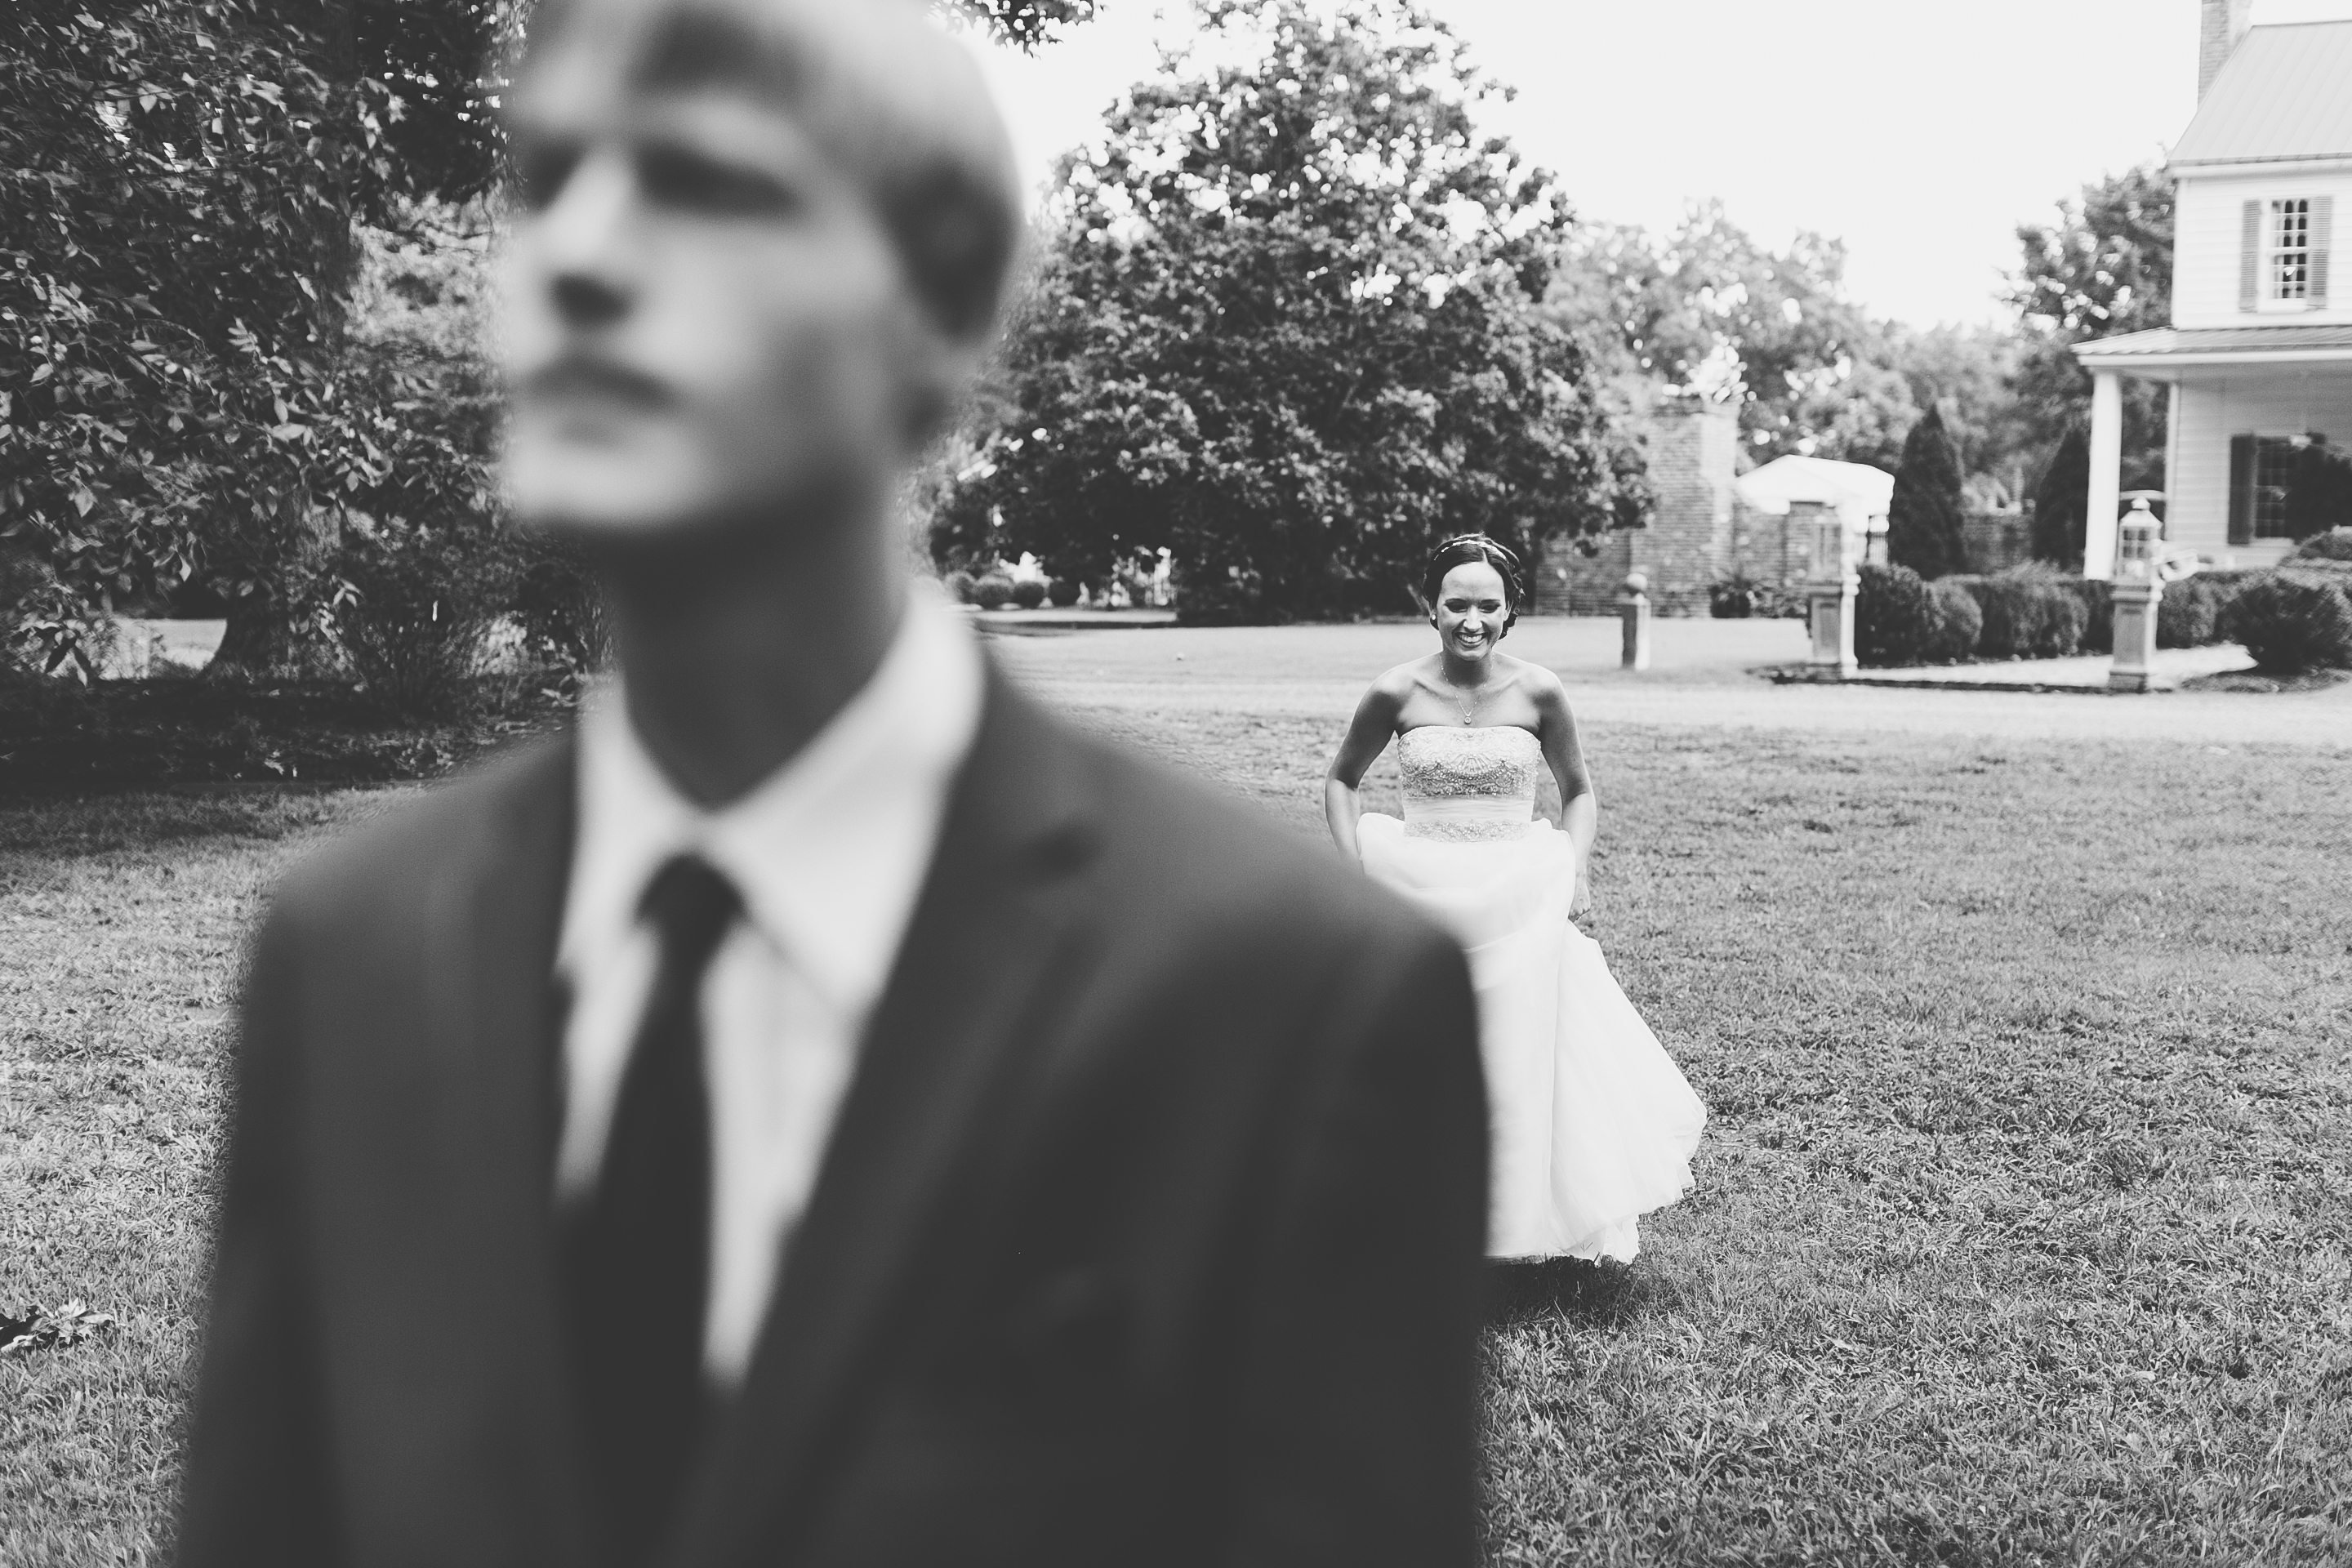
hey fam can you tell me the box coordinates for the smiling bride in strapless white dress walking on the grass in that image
[1324,533,1708,1260]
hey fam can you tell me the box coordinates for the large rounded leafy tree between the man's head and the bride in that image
[933,0,1646,618]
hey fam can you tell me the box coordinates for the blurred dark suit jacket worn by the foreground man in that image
[181,679,1486,1568]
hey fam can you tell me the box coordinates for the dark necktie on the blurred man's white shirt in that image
[562,856,741,1568]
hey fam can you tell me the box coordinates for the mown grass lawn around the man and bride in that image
[0,648,2352,1566]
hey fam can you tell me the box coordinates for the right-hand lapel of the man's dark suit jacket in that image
[668,670,1096,1566]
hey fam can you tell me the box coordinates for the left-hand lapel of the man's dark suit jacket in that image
[428,736,590,1566]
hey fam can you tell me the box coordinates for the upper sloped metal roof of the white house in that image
[2171,21,2352,169]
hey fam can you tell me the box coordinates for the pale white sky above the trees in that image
[964,0,2352,324]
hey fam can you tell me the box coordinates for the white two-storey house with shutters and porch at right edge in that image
[2074,0,2352,578]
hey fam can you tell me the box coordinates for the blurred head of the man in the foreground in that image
[506,0,1018,538]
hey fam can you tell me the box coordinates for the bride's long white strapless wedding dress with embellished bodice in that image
[1357,724,1708,1260]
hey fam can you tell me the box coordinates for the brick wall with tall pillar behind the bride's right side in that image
[1531,397,1740,616]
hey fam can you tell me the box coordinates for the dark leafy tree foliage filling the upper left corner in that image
[0,0,519,663]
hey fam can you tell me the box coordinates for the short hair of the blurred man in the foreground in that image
[522,0,1021,339]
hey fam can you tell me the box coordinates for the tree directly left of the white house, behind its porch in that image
[2009,164,2173,489]
